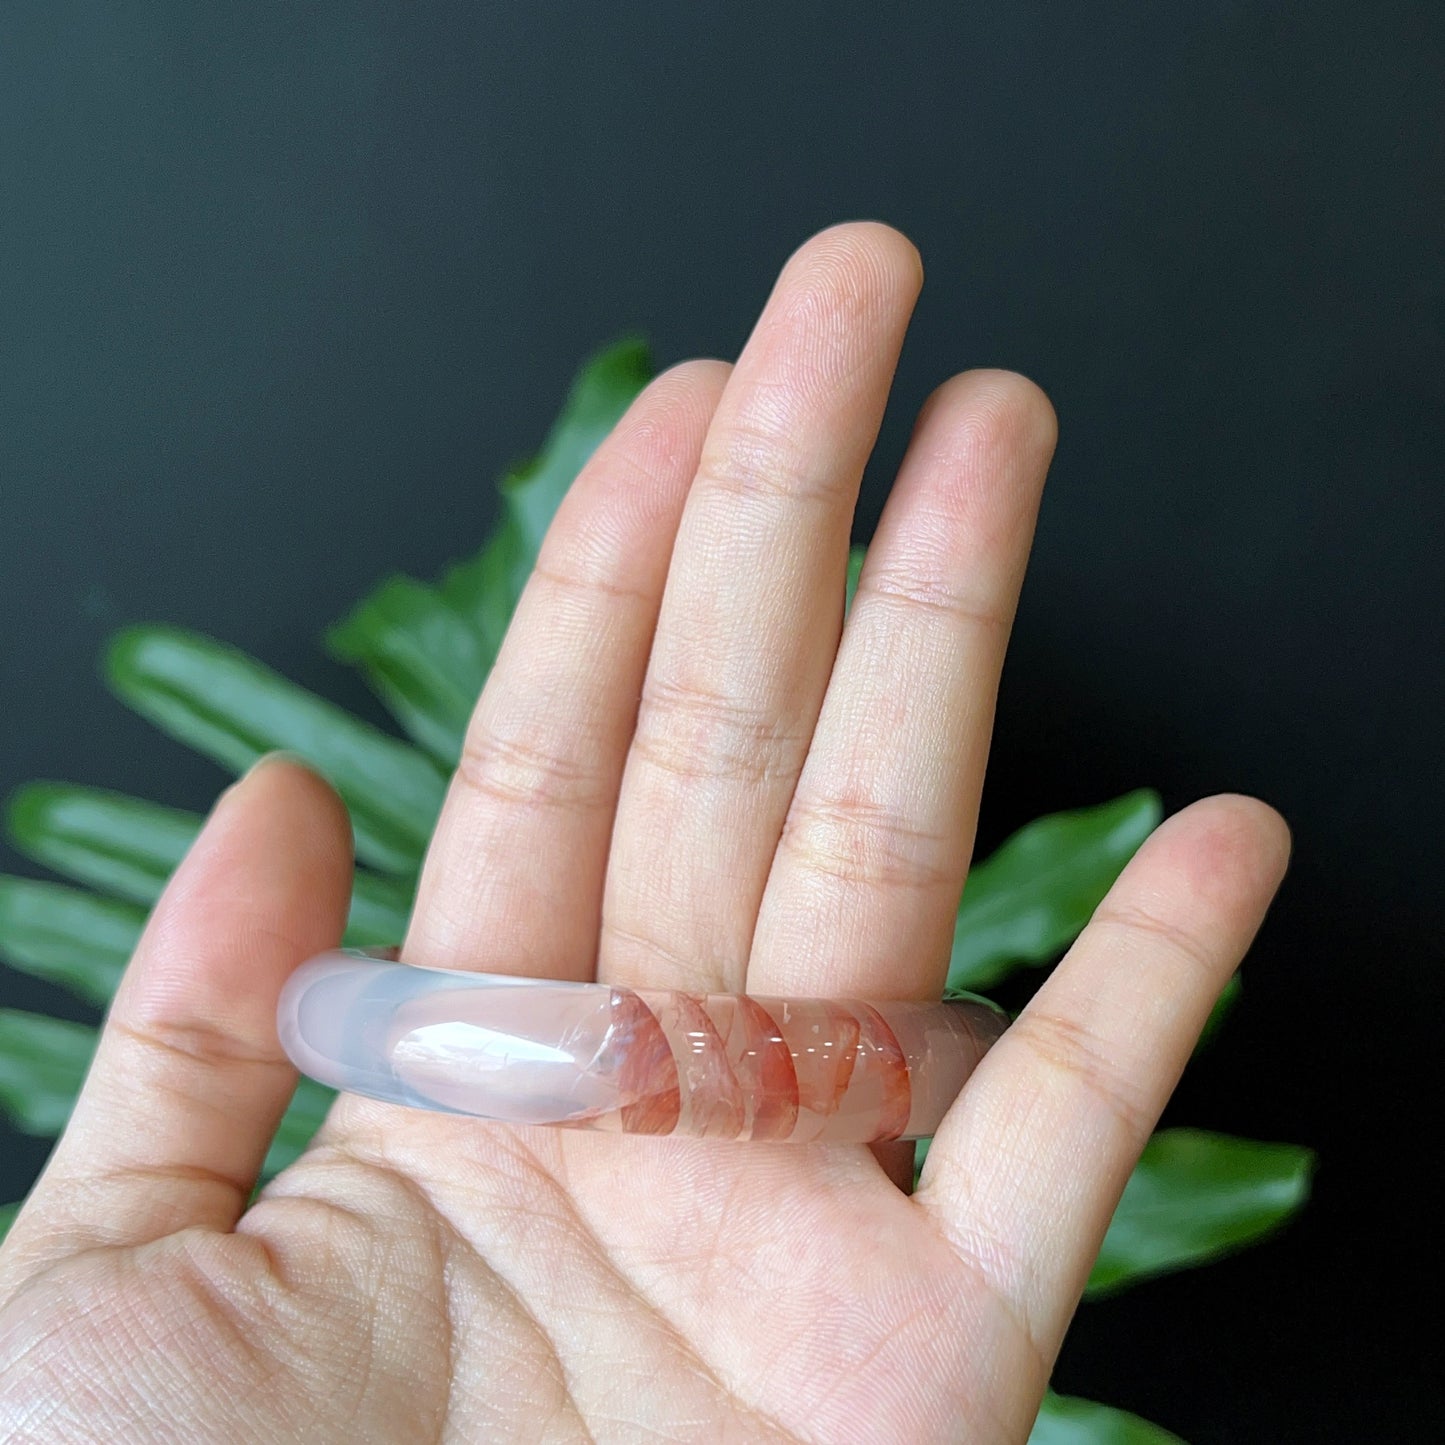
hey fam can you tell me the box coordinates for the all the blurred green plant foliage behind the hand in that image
[0,340,1311,1445]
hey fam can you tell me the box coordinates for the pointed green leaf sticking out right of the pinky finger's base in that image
[1087,1129,1315,1298]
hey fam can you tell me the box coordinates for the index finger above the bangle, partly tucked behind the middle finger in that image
[406,361,728,980]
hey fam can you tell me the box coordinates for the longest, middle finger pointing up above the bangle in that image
[598,224,922,991]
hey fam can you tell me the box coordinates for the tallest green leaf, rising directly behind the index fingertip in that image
[441,337,652,638]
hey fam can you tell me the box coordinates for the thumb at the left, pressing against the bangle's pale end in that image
[4,757,351,1274]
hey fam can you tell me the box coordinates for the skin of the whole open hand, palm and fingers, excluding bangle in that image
[0,224,1289,1445]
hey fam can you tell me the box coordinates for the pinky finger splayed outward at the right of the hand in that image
[915,796,1289,1389]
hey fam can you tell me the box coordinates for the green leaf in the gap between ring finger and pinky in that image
[948,789,1162,993]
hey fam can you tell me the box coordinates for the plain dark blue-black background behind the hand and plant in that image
[0,0,1445,1442]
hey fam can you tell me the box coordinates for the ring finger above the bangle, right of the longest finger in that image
[749,371,1055,998]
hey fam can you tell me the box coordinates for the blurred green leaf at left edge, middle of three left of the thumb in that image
[0,877,146,1007]
